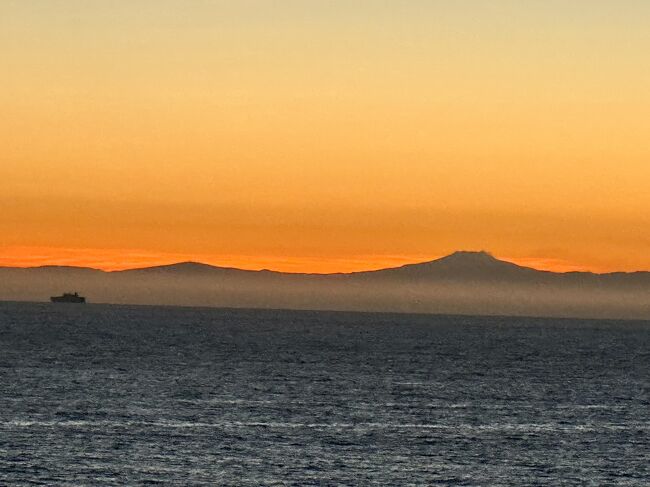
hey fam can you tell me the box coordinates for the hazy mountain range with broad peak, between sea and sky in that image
[0,251,650,320]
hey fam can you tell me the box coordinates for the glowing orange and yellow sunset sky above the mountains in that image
[0,0,650,272]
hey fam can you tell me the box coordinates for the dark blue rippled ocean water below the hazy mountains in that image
[0,303,650,486]
